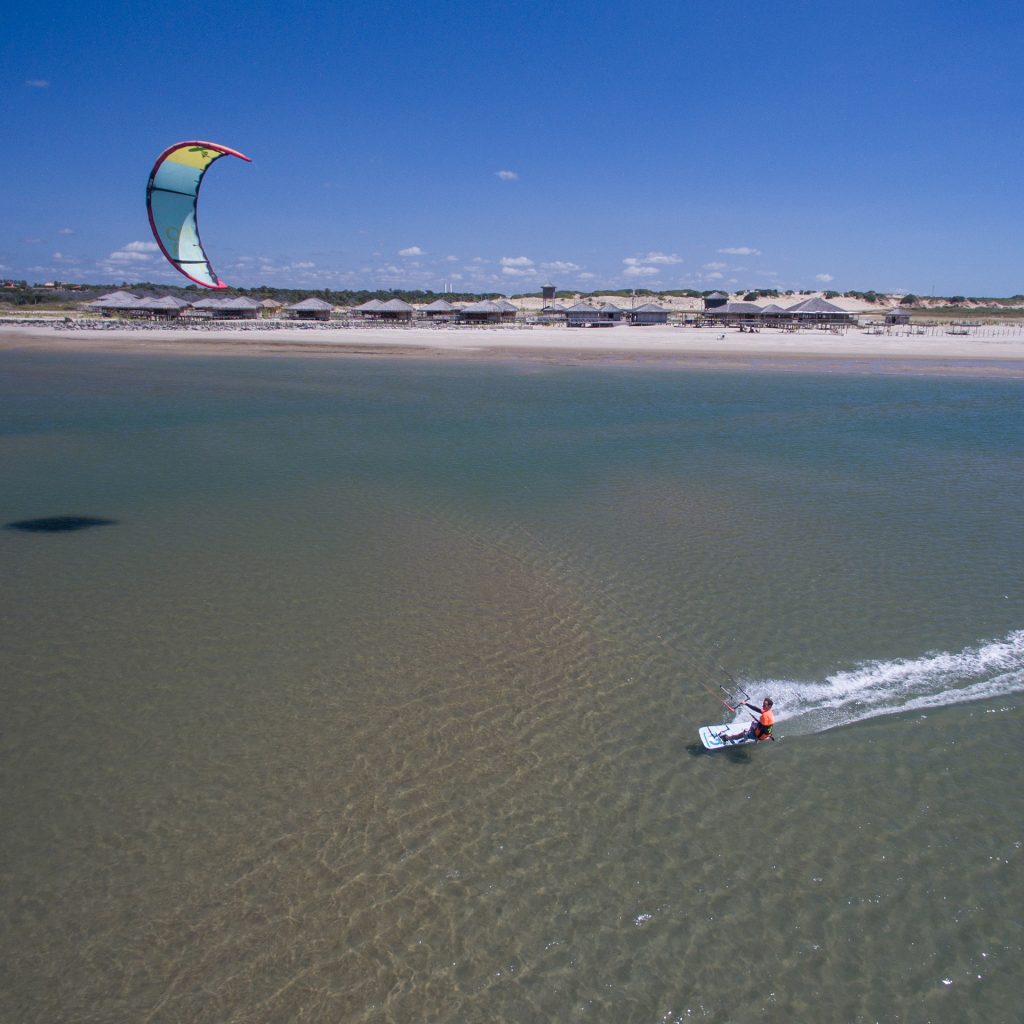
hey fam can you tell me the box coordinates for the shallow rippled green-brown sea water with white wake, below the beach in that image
[0,352,1024,1022]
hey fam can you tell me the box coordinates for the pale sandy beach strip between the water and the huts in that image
[0,322,1024,378]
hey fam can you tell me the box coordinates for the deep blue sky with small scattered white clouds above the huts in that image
[0,0,1024,295]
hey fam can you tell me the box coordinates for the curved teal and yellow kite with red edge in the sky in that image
[145,142,252,288]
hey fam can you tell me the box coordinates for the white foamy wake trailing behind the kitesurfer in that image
[737,630,1024,735]
